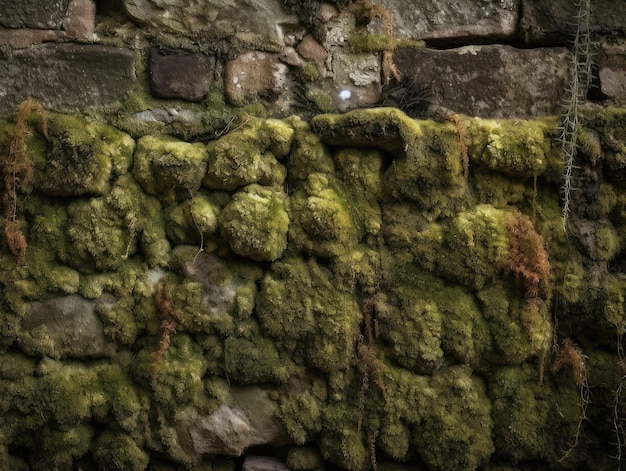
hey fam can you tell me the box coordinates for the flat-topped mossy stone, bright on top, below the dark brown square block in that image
[133,136,208,202]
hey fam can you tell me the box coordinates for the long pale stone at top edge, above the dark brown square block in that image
[124,0,302,51]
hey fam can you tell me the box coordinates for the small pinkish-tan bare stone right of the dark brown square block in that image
[224,51,288,106]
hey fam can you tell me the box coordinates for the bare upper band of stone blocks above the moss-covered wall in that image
[0,0,626,123]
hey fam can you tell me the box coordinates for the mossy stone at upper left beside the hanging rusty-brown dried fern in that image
[34,115,135,196]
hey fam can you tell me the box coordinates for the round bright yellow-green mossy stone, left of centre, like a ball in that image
[219,184,289,261]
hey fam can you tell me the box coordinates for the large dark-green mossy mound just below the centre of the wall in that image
[256,258,360,371]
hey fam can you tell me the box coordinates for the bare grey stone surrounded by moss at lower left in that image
[18,294,115,358]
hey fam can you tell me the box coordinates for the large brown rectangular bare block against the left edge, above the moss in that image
[0,44,136,116]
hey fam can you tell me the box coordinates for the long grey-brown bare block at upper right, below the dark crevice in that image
[394,45,570,118]
